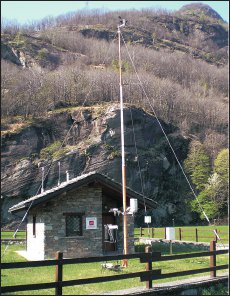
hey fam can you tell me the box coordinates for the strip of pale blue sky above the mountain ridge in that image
[1,1,229,24]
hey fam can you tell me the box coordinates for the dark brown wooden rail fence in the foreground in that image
[0,241,228,296]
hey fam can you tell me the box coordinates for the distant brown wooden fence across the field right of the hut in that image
[135,227,228,242]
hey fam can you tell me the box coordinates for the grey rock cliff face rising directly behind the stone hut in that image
[2,105,191,226]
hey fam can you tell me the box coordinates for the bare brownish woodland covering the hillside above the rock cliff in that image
[1,3,229,224]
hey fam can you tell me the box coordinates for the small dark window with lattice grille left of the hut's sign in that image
[64,213,83,236]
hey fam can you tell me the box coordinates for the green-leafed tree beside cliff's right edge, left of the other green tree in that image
[184,141,211,191]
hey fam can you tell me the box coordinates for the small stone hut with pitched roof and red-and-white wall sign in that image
[9,172,155,260]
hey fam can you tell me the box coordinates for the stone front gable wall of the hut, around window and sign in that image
[39,187,102,258]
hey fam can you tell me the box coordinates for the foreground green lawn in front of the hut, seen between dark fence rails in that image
[2,244,228,295]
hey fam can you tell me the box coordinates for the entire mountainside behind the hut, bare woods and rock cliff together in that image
[1,3,229,225]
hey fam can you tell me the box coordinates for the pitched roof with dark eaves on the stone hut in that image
[9,172,156,212]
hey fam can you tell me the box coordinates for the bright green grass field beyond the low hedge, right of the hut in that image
[134,226,229,244]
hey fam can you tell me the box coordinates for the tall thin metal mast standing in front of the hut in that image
[117,16,128,267]
